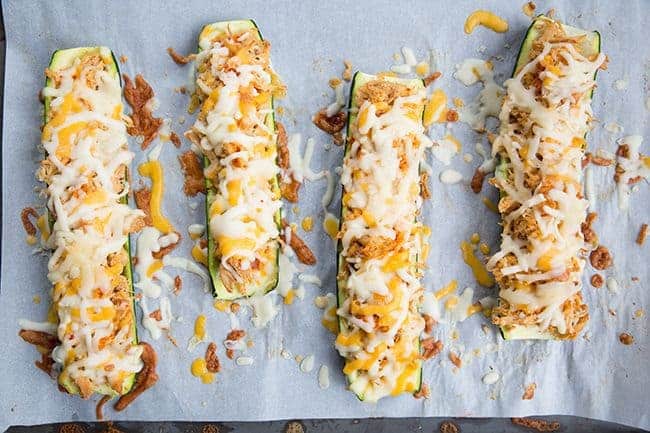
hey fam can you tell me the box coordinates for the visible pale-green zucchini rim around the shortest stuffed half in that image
[198,19,282,300]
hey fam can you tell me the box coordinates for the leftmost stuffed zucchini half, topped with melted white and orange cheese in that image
[37,47,143,398]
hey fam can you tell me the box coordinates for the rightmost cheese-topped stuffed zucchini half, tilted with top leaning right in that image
[488,16,606,340]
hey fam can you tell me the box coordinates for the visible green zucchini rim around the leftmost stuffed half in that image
[43,46,139,397]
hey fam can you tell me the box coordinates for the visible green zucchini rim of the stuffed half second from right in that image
[336,71,426,401]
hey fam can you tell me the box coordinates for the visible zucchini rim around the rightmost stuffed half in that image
[495,15,602,340]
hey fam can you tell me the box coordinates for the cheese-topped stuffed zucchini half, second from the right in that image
[336,72,431,402]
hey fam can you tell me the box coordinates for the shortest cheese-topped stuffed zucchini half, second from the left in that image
[191,20,284,299]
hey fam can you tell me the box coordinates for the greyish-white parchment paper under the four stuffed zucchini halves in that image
[0,0,650,430]
